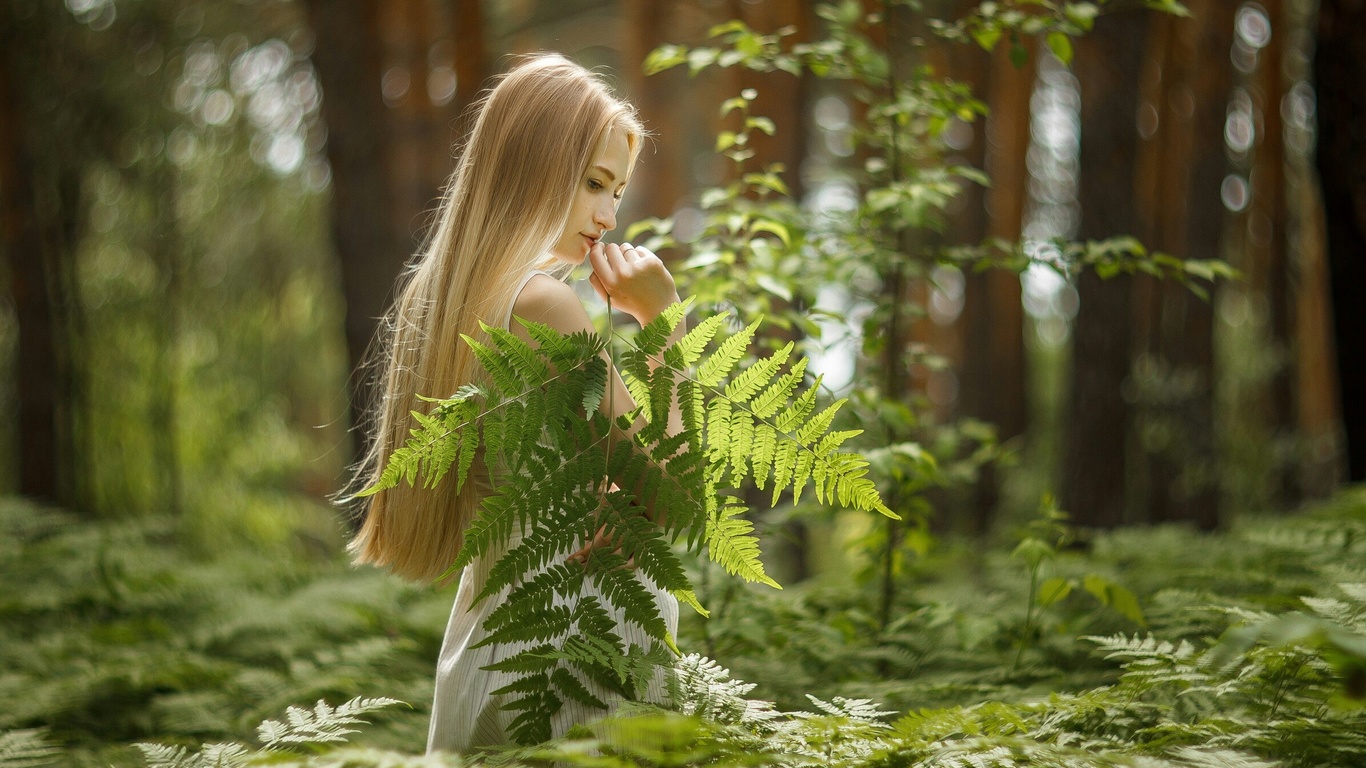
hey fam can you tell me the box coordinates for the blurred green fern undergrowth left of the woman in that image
[0,499,439,767]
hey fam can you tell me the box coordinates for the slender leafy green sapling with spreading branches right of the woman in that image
[627,0,1235,625]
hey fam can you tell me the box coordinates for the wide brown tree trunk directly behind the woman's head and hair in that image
[309,0,488,464]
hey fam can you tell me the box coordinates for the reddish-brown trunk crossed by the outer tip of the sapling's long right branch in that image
[1134,0,1235,530]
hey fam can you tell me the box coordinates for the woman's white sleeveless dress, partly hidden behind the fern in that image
[428,272,679,753]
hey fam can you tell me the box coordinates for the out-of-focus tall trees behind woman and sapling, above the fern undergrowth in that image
[0,0,1366,538]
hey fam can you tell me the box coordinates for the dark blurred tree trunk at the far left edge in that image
[0,3,92,506]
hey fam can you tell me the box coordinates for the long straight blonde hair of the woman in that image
[348,55,645,582]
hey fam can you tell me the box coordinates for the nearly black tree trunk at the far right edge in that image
[1314,0,1366,482]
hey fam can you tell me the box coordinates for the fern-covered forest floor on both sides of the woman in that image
[0,489,1366,767]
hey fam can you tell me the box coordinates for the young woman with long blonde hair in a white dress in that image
[341,55,682,752]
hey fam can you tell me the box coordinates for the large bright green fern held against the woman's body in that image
[363,303,895,743]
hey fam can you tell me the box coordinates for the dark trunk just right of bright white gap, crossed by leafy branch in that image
[1061,12,1149,527]
